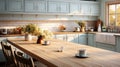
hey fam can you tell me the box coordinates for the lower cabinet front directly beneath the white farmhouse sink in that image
[96,42,116,51]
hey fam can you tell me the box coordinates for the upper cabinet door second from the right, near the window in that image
[81,3,90,15]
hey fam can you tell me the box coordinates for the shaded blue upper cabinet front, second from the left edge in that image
[7,0,24,11]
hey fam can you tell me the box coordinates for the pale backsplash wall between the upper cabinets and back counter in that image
[0,14,97,31]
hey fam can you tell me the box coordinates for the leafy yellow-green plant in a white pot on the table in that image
[23,24,40,41]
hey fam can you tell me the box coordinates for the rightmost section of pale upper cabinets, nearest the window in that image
[70,1,99,16]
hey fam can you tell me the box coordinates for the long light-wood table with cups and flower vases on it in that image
[7,39,120,67]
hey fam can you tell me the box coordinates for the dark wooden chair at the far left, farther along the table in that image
[1,41,16,67]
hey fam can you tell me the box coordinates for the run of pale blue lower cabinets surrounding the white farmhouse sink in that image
[54,33,120,52]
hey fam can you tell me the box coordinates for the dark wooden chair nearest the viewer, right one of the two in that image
[14,51,35,67]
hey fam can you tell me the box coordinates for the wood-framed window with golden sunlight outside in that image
[107,2,120,26]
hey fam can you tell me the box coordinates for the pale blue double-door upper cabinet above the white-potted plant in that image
[25,0,46,13]
